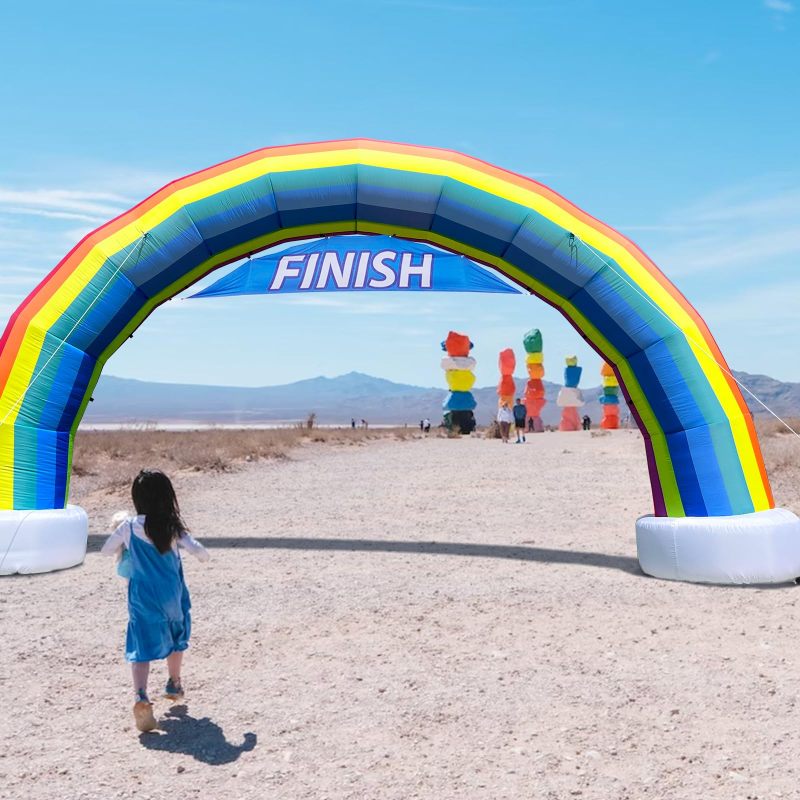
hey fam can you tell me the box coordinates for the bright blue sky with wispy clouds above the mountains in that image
[0,0,800,386]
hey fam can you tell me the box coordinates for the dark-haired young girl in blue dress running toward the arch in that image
[101,470,209,731]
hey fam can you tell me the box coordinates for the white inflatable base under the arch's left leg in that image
[0,506,89,575]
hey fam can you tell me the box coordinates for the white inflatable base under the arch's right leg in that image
[636,508,800,583]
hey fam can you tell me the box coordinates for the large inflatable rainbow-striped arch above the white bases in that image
[0,139,774,517]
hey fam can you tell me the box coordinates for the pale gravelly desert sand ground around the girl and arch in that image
[0,431,800,800]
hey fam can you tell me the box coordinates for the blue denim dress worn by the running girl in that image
[125,523,192,661]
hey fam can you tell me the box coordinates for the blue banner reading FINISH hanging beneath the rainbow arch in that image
[192,235,525,297]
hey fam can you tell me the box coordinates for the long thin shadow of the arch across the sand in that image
[89,534,644,575]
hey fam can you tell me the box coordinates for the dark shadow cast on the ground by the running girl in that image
[139,706,256,766]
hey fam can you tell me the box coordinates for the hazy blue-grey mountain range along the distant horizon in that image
[84,372,800,425]
